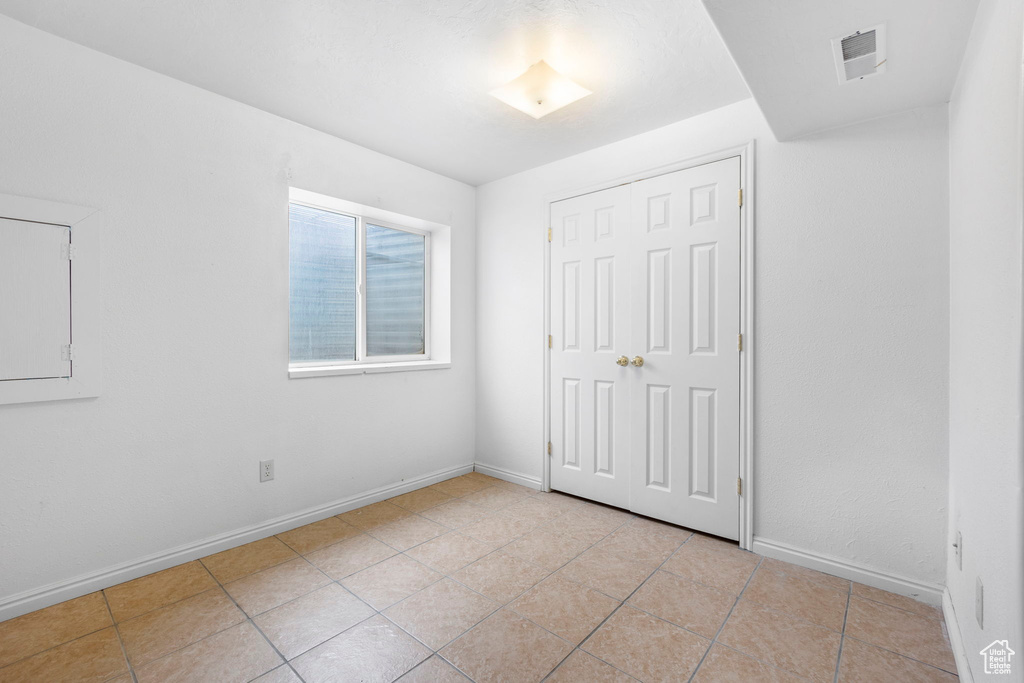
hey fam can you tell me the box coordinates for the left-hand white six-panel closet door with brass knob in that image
[549,186,636,508]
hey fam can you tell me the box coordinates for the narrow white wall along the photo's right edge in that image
[946,0,1024,680]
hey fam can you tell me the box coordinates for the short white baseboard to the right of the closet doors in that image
[752,536,943,606]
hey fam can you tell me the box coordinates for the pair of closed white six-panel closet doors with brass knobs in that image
[549,157,740,540]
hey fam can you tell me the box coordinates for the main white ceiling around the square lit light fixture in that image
[0,0,750,184]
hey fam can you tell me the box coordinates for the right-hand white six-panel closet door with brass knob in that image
[624,157,740,539]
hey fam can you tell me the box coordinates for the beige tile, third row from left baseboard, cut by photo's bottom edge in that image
[135,622,282,683]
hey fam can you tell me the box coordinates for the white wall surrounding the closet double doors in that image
[477,100,948,598]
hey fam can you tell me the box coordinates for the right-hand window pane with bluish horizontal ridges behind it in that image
[367,223,426,355]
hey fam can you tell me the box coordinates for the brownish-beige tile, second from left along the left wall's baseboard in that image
[103,562,217,622]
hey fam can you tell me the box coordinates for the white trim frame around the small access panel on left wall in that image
[0,195,103,405]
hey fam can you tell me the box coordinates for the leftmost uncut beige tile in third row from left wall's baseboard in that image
[253,584,374,659]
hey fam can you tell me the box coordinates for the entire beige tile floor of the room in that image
[0,472,956,683]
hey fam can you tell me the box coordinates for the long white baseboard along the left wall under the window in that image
[0,464,471,622]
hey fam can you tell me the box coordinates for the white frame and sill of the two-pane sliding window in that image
[288,187,452,379]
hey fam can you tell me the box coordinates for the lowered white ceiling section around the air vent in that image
[705,0,978,140]
